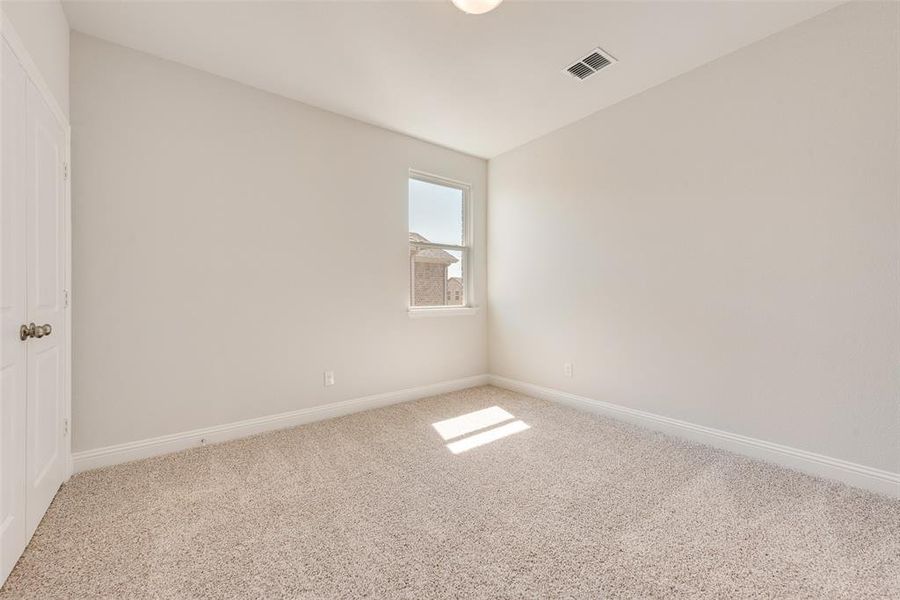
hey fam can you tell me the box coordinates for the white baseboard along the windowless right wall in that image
[489,375,900,498]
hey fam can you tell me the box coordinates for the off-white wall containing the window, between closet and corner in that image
[71,33,487,451]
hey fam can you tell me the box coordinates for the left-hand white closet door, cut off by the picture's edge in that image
[0,39,28,581]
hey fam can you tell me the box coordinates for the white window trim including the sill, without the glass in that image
[406,169,478,318]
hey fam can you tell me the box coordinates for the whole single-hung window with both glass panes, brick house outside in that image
[409,173,469,308]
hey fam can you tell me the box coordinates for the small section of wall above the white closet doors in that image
[0,0,69,116]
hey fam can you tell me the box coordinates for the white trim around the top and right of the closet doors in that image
[0,5,72,479]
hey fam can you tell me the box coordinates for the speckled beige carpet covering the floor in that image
[0,387,900,600]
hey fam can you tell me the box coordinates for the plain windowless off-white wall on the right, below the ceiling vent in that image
[488,2,900,472]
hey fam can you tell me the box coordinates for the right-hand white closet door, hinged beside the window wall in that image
[25,80,67,537]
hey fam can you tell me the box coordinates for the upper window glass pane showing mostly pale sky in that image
[409,179,463,246]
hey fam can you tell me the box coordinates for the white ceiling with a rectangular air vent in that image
[65,0,841,158]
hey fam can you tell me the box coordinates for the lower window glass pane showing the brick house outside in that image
[409,245,466,306]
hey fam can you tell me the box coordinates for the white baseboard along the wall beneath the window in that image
[72,375,488,473]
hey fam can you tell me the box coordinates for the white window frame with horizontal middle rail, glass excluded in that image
[406,169,477,317]
